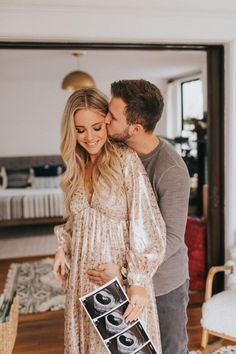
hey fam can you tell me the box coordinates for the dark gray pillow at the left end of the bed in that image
[6,168,30,188]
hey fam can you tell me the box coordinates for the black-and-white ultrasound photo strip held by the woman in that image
[80,278,159,354]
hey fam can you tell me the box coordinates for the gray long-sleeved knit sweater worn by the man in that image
[140,139,190,296]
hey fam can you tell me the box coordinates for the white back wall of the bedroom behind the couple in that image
[0,66,166,156]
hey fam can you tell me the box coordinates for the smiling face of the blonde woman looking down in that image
[74,109,107,161]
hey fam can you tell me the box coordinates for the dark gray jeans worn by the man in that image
[156,280,189,354]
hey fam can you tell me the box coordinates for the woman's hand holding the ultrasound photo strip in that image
[124,285,148,322]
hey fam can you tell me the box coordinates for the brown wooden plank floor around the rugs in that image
[0,257,234,354]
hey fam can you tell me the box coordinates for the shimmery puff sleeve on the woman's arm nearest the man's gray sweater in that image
[124,151,166,286]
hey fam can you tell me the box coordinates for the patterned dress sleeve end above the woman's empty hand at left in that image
[54,216,73,258]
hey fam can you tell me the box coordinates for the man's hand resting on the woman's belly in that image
[87,263,123,285]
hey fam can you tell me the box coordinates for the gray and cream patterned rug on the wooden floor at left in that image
[4,258,65,314]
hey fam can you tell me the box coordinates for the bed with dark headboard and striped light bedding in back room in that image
[0,155,64,226]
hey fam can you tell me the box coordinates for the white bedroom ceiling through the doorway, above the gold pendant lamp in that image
[0,49,206,81]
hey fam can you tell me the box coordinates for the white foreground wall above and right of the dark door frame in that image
[0,0,236,252]
